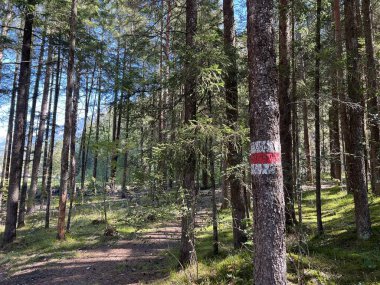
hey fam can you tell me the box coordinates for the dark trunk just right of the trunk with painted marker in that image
[278,0,296,226]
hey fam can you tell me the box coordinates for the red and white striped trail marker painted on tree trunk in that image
[249,141,281,175]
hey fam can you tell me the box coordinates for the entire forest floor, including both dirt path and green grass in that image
[0,183,380,285]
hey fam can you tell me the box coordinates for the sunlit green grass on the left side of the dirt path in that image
[0,194,177,274]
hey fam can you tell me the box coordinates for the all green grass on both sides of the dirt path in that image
[0,187,380,284]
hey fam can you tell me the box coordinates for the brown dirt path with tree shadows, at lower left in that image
[0,221,180,285]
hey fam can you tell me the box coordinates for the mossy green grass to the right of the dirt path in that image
[162,187,380,284]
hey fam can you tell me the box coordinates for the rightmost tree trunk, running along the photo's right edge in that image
[362,0,380,195]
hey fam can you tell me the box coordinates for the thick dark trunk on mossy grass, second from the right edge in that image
[344,0,371,239]
